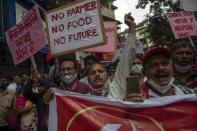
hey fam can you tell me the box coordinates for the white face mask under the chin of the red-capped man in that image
[147,77,175,94]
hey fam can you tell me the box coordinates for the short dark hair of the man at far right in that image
[171,41,193,52]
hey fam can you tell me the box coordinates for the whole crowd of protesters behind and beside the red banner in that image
[0,15,197,131]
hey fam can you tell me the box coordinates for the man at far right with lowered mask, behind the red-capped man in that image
[171,41,197,88]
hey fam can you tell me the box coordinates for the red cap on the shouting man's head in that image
[141,47,172,66]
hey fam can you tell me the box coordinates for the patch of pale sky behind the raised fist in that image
[114,0,149,32]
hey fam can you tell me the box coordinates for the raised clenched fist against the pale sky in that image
[124,13,136,34]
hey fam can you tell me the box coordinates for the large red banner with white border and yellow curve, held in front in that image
[49,89,197,131]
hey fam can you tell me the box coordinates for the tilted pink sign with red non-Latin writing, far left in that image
[6,6,46,65]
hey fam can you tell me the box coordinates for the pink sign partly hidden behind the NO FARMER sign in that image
[85,21,117,53]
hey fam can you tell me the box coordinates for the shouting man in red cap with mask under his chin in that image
[124,47,193,102]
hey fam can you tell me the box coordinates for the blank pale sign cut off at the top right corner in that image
[180,0,197,11]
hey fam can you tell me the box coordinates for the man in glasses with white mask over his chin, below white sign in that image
[43,58,90,103]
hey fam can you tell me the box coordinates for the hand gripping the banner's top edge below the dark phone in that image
[123,93,144,102]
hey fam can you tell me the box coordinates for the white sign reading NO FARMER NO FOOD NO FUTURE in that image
[45,0,106,56]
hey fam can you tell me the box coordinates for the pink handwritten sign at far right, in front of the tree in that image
[167,12,197,39]
